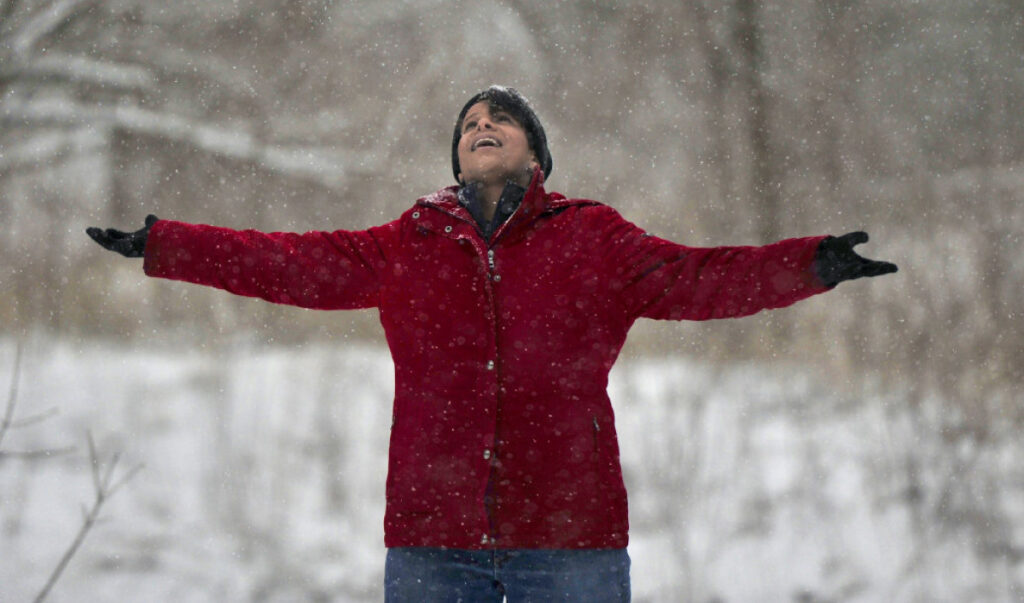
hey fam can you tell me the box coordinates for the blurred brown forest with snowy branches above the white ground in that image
[0,0,1024,597]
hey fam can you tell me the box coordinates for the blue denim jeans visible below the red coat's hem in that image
[384,547,630,603]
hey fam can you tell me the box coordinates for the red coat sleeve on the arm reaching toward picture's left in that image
[143,220,397,310]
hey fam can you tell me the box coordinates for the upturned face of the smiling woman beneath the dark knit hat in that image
[458,101,538,185]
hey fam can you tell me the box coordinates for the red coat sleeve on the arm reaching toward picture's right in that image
[601,207,828,320]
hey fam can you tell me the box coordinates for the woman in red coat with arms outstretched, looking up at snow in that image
[88,86,896,602]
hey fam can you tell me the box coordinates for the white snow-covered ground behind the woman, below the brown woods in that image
[0,340,1024,603]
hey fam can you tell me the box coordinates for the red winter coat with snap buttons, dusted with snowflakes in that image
[144,168,826,549]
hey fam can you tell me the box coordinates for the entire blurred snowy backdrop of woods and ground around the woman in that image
[0,0,1024,603]
